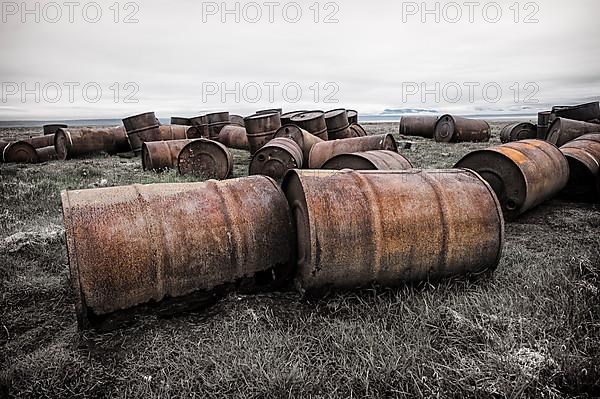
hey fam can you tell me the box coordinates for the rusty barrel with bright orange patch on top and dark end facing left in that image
[455,140,569,220]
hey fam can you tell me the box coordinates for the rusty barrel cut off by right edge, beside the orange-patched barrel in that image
[560,134,600,201]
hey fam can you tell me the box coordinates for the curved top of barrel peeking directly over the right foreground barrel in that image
[321,150,413,170]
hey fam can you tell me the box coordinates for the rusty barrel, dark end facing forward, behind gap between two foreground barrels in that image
[249,137,303,180]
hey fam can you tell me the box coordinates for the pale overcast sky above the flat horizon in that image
[0,0,600,120]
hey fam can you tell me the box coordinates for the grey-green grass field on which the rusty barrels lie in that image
[0,122,600,399]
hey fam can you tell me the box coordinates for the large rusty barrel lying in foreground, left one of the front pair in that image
[62,176,294,328]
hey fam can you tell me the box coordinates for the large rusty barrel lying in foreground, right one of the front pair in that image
[283,169,504,293]
